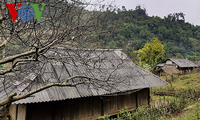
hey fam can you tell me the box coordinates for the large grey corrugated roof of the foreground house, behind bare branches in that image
[0,48,168,104]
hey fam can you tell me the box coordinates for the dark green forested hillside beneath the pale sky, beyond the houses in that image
[93,6,200,61]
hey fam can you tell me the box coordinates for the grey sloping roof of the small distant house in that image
[169,58,198,67]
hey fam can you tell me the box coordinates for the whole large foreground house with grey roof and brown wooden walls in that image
[0,48,168,120]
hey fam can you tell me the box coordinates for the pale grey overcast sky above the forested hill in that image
[101,0,200,25]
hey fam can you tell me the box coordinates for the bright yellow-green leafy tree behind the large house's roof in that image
[138,38,165,69]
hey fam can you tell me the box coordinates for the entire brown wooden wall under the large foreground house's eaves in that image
[10,88,149,120]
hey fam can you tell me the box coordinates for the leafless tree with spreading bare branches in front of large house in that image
[0,0,117,118]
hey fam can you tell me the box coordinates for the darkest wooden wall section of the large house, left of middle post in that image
[27,97,101,120]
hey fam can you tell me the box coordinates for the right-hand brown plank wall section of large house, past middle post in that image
[103,88,149,115]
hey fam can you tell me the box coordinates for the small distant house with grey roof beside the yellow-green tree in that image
[157,58,198,74]
